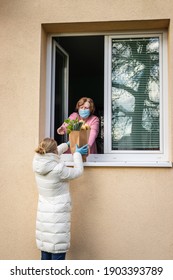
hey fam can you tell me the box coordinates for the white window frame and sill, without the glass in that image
[45,30,172,167]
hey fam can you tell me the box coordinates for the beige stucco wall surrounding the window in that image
[0,0,173,259]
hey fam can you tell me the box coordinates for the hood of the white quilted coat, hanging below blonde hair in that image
[32,153,60,175]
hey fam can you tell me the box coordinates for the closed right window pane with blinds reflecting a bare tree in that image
[112,37,160,150]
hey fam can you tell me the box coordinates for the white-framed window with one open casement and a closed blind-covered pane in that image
[48,31,171,166]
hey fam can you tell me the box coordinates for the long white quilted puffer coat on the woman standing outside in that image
[33,143,83,253]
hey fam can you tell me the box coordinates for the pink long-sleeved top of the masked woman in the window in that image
[63,113,99,154]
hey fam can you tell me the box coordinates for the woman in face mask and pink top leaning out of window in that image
[57,97,99,154]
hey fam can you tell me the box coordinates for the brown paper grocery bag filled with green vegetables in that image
[64,118,90,161]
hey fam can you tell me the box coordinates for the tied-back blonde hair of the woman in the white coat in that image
[35,138,57,155]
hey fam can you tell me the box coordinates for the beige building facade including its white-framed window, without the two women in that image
[0,0,173,260]
